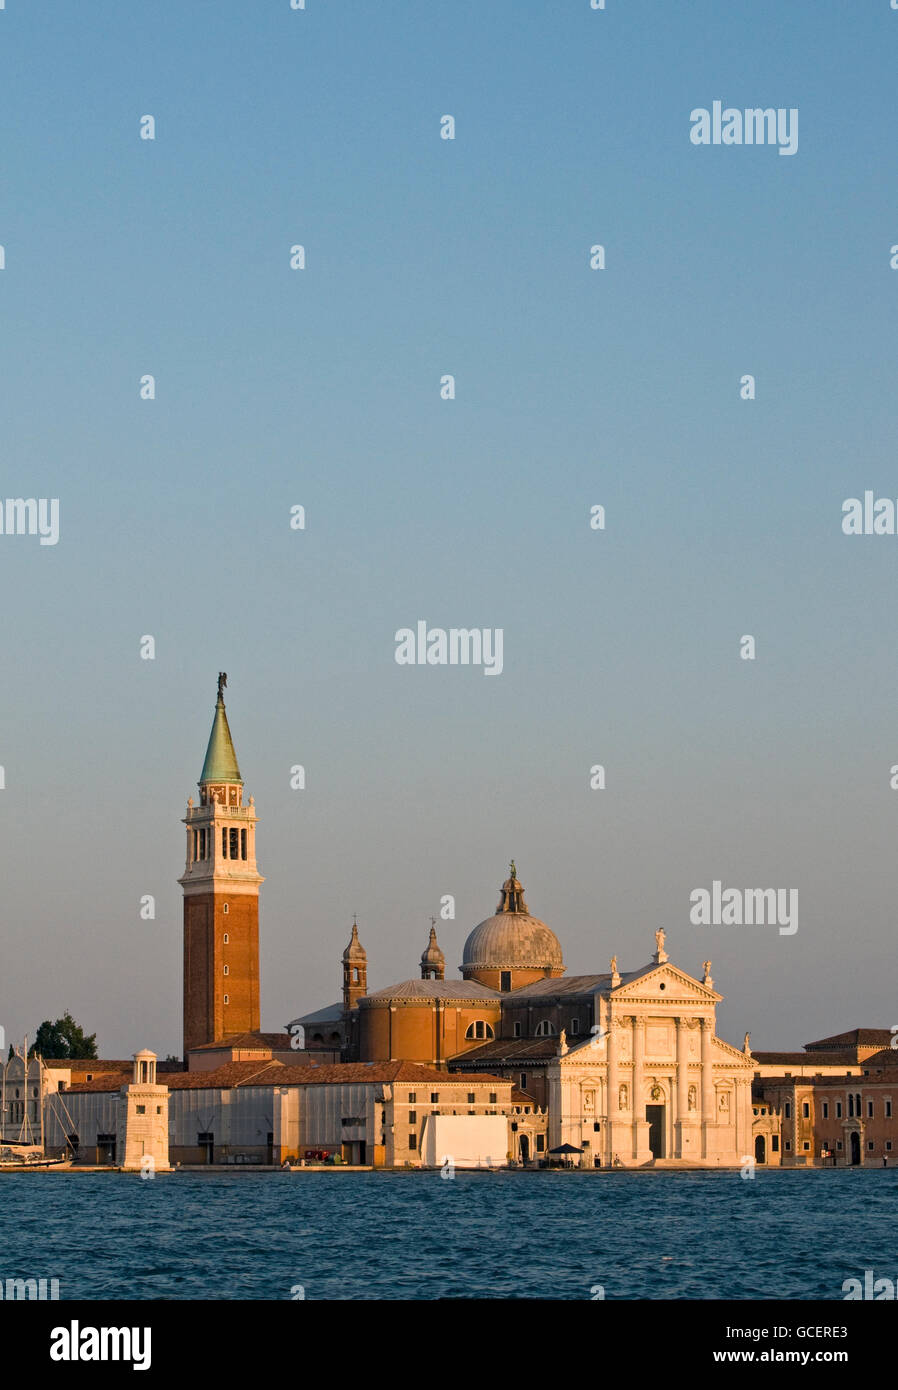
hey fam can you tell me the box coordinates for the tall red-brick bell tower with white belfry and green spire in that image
[178,671,264,1065]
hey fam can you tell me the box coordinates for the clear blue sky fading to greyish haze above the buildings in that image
[0,0,898,1056]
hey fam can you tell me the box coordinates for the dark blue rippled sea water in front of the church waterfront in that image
[0,1169,898,1300]
